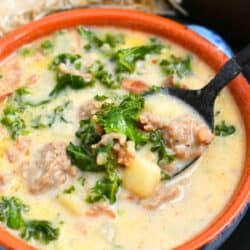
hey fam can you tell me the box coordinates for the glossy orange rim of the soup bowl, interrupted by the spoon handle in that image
[0,8,250,250]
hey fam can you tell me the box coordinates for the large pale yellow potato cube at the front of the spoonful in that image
[123,156,161,198]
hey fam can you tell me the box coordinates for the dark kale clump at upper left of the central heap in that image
[76,119,101,146]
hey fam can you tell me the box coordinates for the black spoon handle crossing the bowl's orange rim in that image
[201,44,250,102]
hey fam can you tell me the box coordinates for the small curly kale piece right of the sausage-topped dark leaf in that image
[89,61,118,88]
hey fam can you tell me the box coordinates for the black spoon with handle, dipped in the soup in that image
[155,44,250,177]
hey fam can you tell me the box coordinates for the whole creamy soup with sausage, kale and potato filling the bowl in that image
[0,27,245,250]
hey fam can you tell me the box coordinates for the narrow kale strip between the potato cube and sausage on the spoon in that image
[150,130,176,164]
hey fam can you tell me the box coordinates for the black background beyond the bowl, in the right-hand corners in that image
[170,0,250,250]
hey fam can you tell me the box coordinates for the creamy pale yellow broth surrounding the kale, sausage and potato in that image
[0,28,245,250]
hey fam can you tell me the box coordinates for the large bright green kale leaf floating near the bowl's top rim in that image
[113,44,163,74]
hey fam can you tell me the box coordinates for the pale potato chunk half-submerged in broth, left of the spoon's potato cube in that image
[57,194,86,215]
